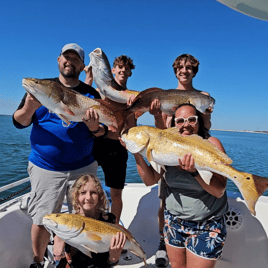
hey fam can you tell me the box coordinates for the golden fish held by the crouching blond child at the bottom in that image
[43,213,147,265]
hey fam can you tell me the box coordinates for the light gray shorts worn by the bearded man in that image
[28,161,98,225]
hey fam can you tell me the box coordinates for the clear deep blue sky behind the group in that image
[0,0,268,131]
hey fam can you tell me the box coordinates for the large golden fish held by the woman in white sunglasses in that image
[121,126,268,215]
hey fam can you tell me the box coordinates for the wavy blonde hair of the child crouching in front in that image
[70,174,109,214]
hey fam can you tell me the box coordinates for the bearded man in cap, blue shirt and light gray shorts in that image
[13,43,108,268]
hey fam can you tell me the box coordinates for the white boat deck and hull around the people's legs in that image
[0,179,268,268]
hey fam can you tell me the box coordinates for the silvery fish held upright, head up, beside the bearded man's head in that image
[89,48,139,104]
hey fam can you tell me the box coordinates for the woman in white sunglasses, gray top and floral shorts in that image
[122,104,228,268]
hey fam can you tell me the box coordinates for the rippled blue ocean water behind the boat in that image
[0,115,268,198]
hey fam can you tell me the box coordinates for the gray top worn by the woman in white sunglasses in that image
[165,167,228,221]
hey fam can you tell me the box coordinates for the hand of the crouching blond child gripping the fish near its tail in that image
[109,232,126,263]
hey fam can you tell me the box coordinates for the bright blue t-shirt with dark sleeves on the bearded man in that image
[13,78,100,171]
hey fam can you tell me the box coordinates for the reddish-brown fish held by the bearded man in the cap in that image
[22,78,125,132]
